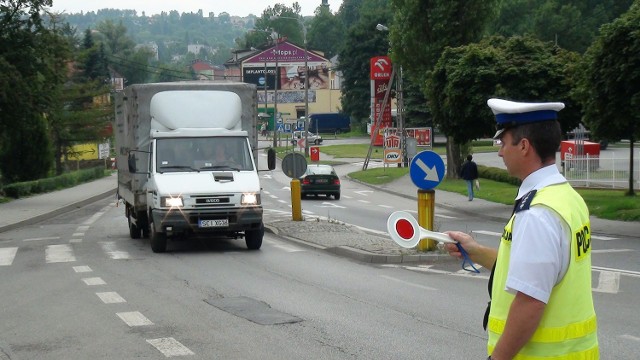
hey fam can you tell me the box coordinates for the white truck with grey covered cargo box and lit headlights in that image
[114,81,275,252]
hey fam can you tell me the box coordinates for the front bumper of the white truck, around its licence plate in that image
[151,207,262,236]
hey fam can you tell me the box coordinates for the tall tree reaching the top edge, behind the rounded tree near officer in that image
[389,0,498,177]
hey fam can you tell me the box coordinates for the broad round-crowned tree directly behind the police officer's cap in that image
[428,37,580,176]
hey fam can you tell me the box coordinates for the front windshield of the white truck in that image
[156,137,254,173]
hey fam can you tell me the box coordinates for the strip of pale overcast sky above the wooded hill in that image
[51,0,342,16]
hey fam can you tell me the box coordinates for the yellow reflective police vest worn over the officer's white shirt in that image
[487,183,599,360]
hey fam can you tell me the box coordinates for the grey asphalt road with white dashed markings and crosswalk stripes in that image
[0,159,640,359]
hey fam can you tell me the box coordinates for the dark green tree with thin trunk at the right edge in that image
[576,1,640,195]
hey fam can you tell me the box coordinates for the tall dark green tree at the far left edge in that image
[0,0,60,182]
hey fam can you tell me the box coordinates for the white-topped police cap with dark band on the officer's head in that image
[487,99,564,139]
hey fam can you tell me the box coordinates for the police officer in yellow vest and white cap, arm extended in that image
[445,99,600,360]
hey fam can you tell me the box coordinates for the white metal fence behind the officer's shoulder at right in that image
[563,152,640,190]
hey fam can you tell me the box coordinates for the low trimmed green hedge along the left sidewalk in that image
[1,166,110,199]
